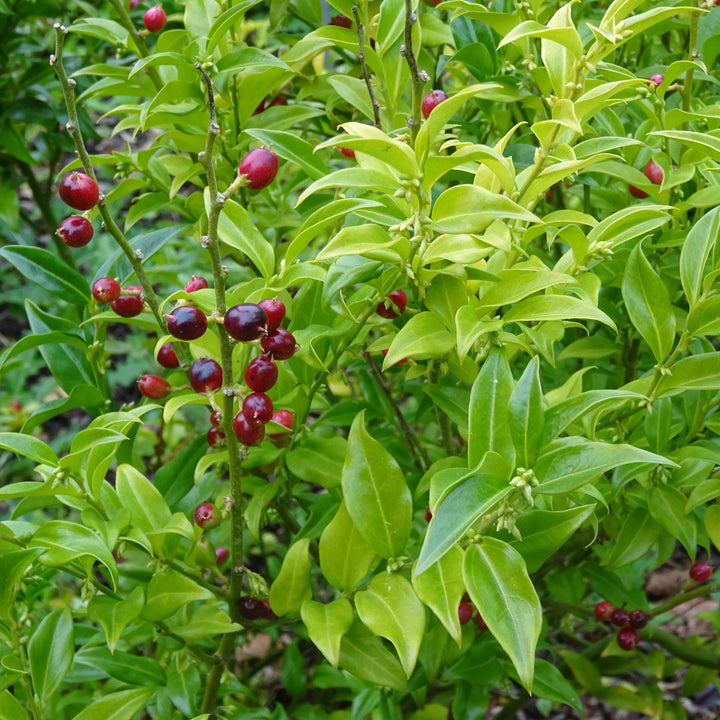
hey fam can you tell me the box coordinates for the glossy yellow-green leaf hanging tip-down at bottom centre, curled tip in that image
[355,572,425,678]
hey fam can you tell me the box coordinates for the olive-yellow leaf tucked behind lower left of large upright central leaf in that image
[319,501,376,592]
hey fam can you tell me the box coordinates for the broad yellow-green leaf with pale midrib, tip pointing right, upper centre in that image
[432,186,540,233]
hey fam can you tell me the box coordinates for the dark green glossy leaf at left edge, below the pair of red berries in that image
[0,245,90,305]
